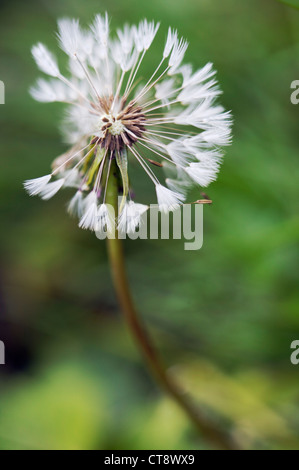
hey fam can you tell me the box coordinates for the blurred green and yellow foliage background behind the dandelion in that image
[0,0,299,450]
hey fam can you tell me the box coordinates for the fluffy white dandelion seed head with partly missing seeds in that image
[24,13,232,233]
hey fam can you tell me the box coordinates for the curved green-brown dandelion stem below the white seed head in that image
[107,165,239,450]
